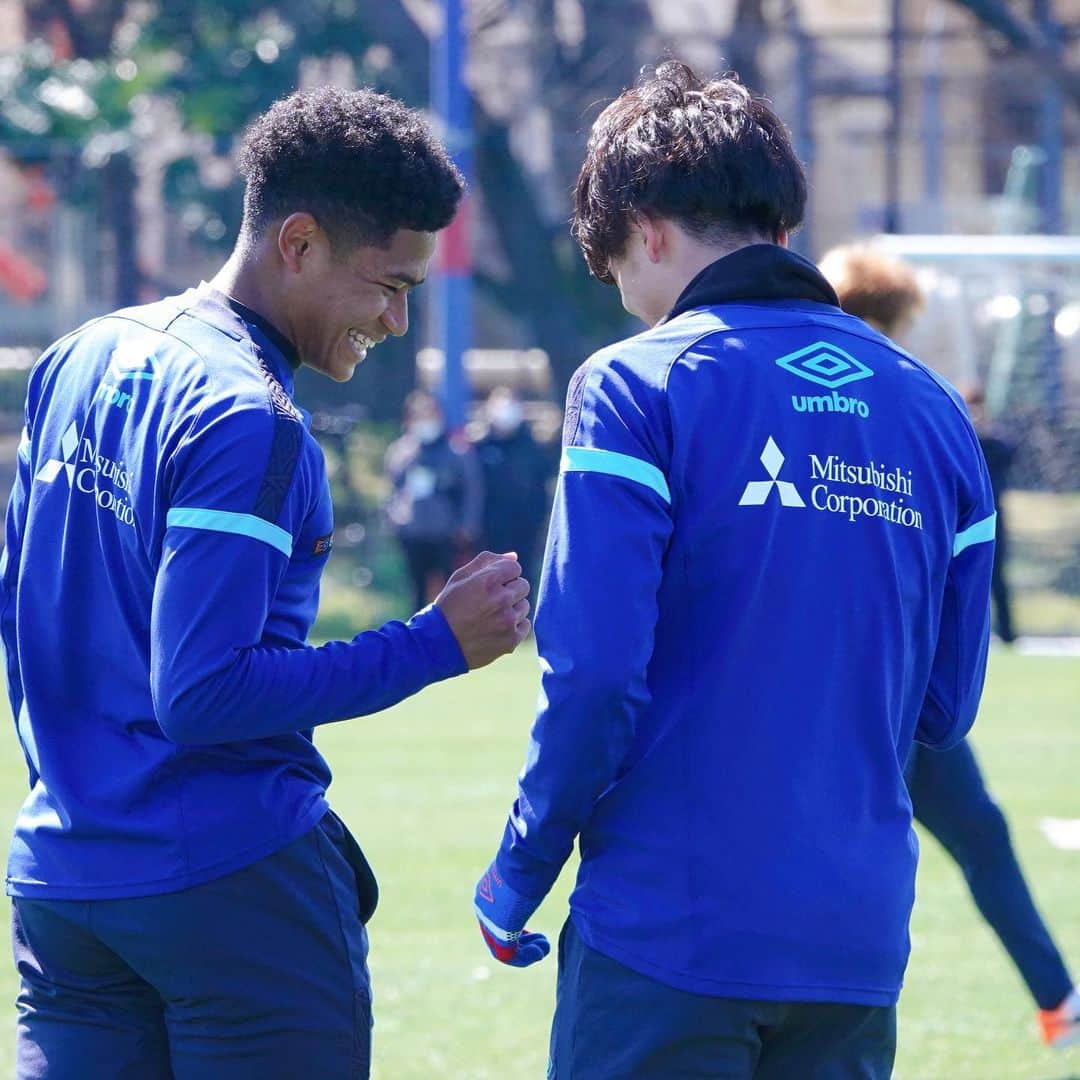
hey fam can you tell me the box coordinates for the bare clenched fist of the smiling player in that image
[435,551,531,669]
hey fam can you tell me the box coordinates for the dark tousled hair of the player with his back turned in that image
[572,60,807,285]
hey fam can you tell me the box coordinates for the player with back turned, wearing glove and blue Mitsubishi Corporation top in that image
[475,62,994,1080]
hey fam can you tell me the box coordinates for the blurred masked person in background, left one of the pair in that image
[386,390,483,607]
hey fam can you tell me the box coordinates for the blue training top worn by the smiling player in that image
[0,285,465,899]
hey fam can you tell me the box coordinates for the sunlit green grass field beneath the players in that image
[0,649,1080,1080]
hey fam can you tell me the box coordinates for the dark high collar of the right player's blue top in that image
[665,244,840,321]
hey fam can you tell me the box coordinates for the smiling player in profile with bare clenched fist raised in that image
[0,87,529,1080]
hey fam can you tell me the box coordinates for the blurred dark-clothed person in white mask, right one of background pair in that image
[476,387,554,580]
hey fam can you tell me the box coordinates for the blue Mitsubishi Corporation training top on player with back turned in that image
[497,245,995,1005]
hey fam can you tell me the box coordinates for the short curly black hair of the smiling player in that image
[240,86,464,252]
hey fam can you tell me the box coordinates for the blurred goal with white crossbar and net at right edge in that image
[873,235,1080,635]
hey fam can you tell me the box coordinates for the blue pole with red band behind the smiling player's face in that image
[431,0,473,428]
